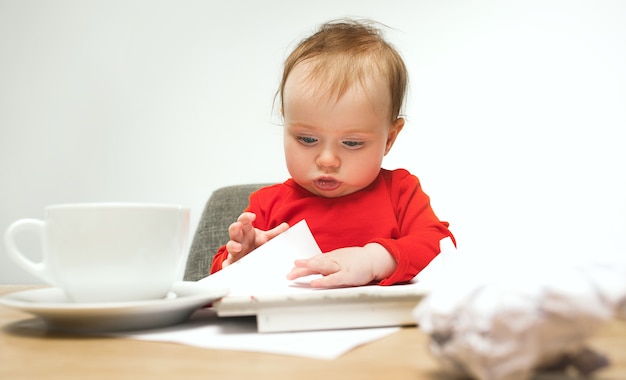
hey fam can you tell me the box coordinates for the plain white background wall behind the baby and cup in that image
[0,0,626,283]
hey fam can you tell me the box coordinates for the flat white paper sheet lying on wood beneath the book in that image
[115,309,399,360]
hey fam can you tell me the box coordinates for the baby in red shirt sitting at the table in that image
[211,20,454,287]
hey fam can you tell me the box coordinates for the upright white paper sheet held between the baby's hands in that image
[198,220,322,296]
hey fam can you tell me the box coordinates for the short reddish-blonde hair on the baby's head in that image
[276,19,408,121]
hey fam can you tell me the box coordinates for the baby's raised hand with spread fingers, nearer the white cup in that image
[222,212,289,267]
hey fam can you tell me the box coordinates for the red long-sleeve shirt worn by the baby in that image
[211,169,454,285]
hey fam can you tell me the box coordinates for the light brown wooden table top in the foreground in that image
[0,285,626,380]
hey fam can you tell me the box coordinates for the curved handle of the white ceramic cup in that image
[4,219,55,285]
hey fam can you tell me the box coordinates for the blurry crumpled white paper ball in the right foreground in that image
[414,251,626,380]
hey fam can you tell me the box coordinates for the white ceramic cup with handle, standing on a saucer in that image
[4,203,189,302]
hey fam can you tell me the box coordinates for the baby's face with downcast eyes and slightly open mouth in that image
[283,65,404,198]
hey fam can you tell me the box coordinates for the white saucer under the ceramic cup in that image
[0,281,228,332]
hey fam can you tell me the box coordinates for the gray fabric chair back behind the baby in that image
[184,183,269,281]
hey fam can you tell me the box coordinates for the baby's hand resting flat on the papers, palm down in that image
[287,243,397,288]
